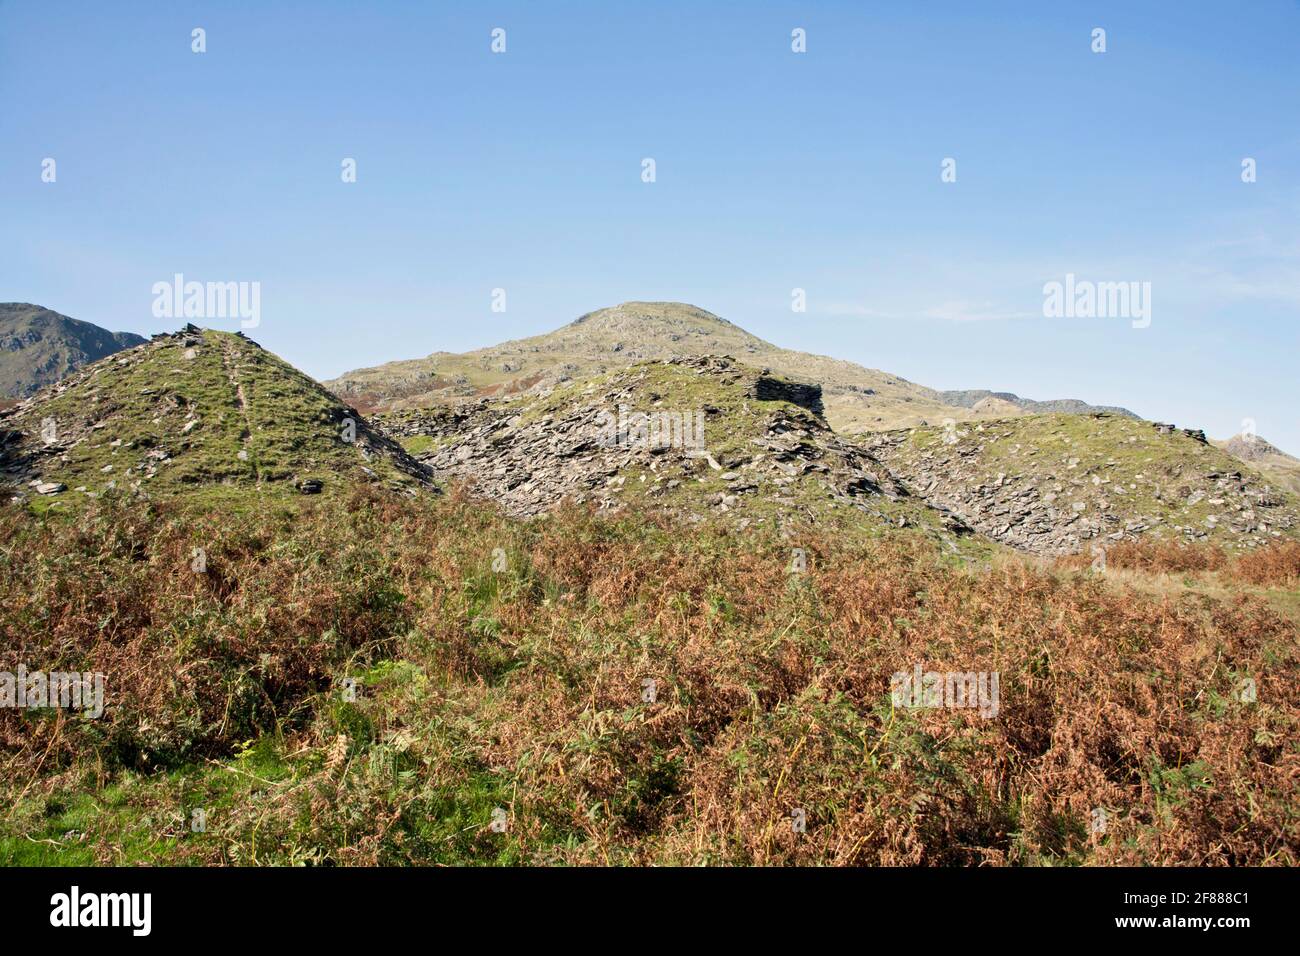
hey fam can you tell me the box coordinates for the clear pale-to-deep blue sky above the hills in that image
[0,0,1300,453]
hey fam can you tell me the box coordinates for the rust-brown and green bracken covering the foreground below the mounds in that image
[0,496,1300,865]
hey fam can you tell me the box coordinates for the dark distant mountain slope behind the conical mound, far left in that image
[0,302,144,398]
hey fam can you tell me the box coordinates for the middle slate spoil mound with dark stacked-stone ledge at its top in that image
[376,356,904,516]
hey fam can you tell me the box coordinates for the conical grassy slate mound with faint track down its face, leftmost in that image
[0,325,428,505]
